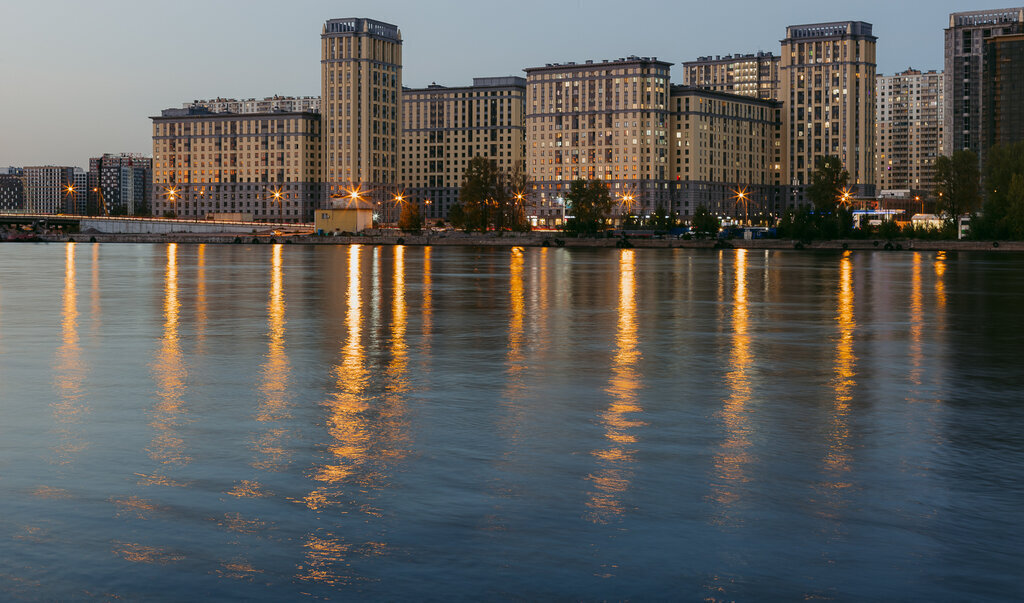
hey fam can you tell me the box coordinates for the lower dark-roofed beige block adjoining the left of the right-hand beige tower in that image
[669,86,784,221]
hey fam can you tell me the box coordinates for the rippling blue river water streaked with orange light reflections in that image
[0,244,1024,600]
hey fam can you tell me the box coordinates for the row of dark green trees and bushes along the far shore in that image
[399,142,1024,240]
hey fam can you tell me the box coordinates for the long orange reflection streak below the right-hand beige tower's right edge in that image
[822,251,857,495]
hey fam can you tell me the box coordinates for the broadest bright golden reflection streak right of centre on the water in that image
[587,250,645,523]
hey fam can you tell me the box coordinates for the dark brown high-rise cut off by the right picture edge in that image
[982,34,1024,158]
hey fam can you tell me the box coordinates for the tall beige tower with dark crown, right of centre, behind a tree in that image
[780,20,878,196]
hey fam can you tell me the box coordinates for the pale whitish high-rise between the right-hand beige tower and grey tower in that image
[874,69,945,196]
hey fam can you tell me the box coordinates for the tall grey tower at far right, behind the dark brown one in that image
[943,8,1024,156]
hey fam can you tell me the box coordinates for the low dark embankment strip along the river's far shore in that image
[24,232,1024,252]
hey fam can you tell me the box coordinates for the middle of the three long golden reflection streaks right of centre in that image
[711,249,753,524]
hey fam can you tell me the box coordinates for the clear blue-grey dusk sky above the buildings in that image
[0,0,983,168]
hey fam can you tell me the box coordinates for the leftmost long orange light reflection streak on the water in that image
[51,243,86,465]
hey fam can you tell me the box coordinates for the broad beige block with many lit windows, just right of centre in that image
[524,56,672,225]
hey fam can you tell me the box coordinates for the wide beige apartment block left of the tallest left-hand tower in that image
[151,107,322,222]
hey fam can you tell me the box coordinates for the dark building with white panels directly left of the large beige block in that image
[84,153,153,215]
